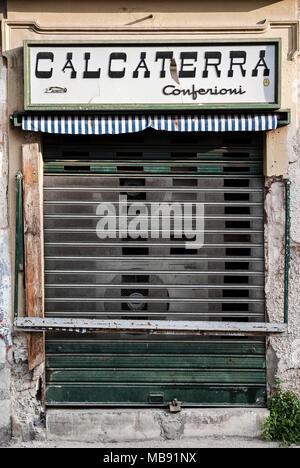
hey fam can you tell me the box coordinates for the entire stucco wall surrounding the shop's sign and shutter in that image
[0,0,300,439]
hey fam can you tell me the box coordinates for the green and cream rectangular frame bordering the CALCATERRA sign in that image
[23,38,282,112]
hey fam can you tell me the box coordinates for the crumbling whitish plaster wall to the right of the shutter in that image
[265,2,300,398]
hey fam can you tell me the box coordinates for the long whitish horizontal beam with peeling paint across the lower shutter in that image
[14,317,287,336]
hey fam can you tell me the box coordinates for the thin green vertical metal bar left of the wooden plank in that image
[14,172,24,317]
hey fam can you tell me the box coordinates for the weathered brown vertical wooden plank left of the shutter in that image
[22,143,45,370]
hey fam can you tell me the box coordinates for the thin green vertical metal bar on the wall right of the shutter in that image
[284,179,291,323]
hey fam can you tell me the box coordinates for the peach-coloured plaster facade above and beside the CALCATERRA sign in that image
[3,0,299,176]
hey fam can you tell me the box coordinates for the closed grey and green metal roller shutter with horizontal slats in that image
[44,130,266,406]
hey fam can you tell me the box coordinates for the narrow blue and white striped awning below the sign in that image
[22,114,277,135]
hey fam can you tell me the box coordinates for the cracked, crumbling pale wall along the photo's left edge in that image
[0,40,44,444]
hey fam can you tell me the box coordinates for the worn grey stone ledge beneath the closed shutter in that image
[46,408,269,443]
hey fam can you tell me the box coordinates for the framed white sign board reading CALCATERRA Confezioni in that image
[24,40,280,110]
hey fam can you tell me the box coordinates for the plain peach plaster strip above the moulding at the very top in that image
[3,0,296,27]
